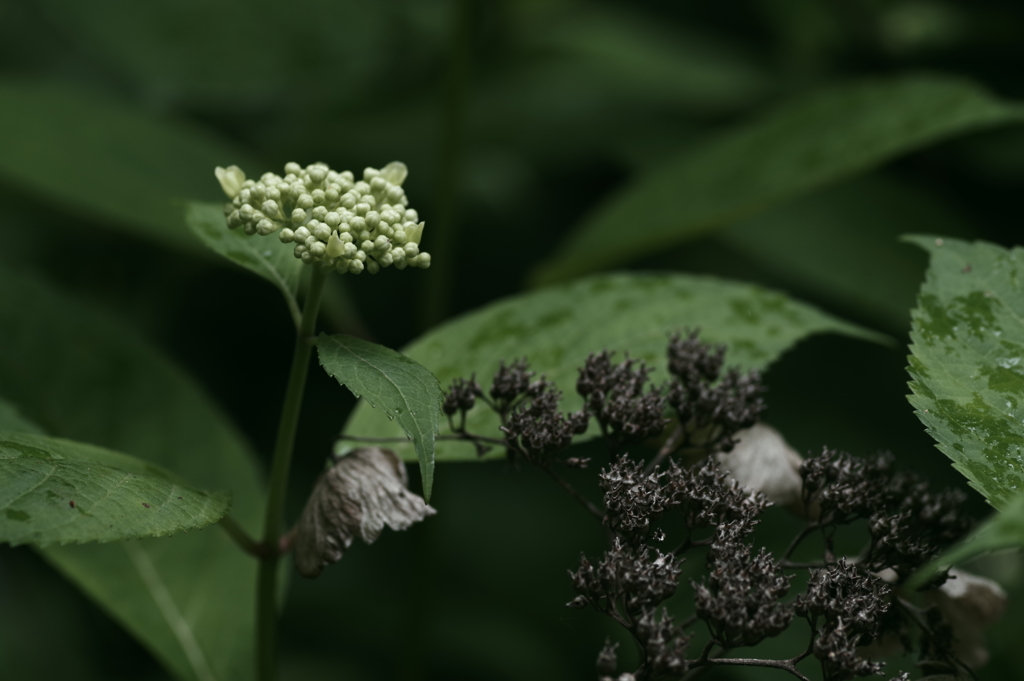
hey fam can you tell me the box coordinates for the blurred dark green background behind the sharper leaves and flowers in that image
[0,0,1024,681]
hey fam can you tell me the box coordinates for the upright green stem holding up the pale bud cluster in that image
[256,265,328,681]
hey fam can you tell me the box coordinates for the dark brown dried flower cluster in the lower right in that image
[346,333,1001,681]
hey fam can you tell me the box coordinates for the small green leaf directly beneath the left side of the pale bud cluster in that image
[185,203,303,326]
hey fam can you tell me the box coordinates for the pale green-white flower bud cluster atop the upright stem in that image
[215,161,430,274]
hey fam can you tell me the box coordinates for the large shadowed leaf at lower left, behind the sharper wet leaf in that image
[0,268,262,681]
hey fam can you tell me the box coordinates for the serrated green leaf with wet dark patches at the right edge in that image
[907,237,1024,508]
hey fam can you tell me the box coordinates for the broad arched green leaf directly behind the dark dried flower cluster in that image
[345,274,881,461]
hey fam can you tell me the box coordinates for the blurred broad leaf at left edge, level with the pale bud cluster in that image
[0,81,255,251]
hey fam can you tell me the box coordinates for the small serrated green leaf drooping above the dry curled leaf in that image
[316,334,443,501]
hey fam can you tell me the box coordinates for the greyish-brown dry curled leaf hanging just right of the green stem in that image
[293,446,436,578]
